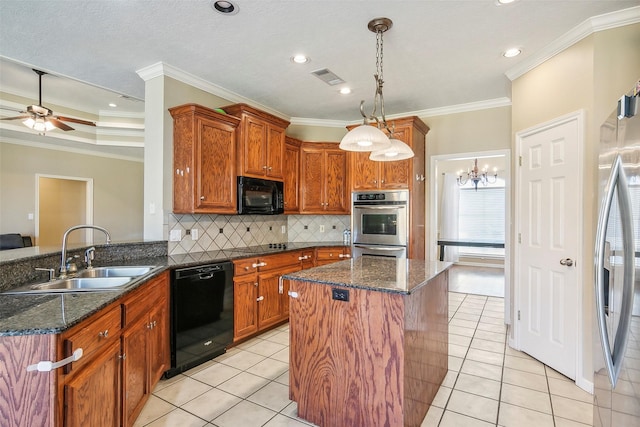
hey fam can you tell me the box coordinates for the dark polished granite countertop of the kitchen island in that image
[283,257,451,294]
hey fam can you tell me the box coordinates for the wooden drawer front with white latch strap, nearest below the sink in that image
[62,305,122,374]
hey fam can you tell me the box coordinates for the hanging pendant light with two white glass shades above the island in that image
[340,18,414,161]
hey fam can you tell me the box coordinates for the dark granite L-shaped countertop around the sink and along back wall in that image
[0,242,343,336]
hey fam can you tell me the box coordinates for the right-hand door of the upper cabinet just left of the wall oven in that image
[324,150,350,214]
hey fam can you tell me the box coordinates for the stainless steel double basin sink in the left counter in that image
[4,266,159,294]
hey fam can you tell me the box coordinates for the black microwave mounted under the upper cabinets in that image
[238,176,284,215]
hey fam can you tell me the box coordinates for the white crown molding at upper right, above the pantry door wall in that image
[505,6,640,81]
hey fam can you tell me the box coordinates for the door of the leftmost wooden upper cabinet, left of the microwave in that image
[195,119,236,213]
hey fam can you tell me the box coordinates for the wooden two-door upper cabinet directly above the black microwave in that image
[222,104,289,181]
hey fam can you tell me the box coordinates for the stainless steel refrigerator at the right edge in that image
[593,82,640,427]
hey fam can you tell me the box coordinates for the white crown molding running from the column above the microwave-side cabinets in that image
[136,62,290,121]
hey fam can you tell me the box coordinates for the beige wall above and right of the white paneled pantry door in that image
[512,24,640,386]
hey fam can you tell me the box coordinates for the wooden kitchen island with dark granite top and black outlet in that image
[283,257,450,426]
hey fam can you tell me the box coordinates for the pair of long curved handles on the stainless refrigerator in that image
[595,155,635,387]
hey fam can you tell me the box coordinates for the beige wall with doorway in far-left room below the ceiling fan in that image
[0,141,143,242]
